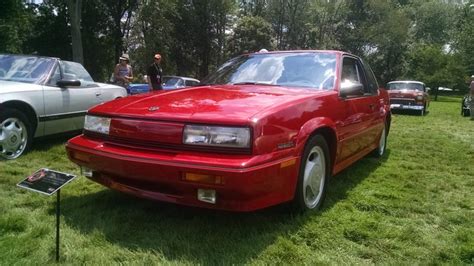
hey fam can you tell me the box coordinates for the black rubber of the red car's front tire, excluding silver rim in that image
[293,135,331,212]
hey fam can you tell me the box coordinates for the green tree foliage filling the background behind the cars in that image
[0,0,474,90]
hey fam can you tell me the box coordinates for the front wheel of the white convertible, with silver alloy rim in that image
[0,109,33,160]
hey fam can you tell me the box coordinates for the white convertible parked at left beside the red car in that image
[0,54,126,159]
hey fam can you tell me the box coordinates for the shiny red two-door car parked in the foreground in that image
[66,51,391,211]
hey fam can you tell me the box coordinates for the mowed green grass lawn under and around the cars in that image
[0,97,474,265]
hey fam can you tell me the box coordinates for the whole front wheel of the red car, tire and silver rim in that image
[292,135,331,212]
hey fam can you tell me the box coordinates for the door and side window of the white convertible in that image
[40,61,101,135]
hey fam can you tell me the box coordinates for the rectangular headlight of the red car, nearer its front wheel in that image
[183,125,250,148]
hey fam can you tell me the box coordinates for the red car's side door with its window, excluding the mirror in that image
[337,56,381,163]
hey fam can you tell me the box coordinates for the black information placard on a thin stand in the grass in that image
[17,168,76,196]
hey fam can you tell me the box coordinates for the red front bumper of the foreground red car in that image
[66,135,300,211]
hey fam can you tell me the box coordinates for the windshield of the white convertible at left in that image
[0,55,55,83]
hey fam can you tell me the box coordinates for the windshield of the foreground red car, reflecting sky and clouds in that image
[202,52,336,90]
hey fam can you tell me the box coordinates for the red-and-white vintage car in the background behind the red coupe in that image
[387,80,430,116]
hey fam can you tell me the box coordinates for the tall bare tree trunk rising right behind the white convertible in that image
[67,0,84,64]
